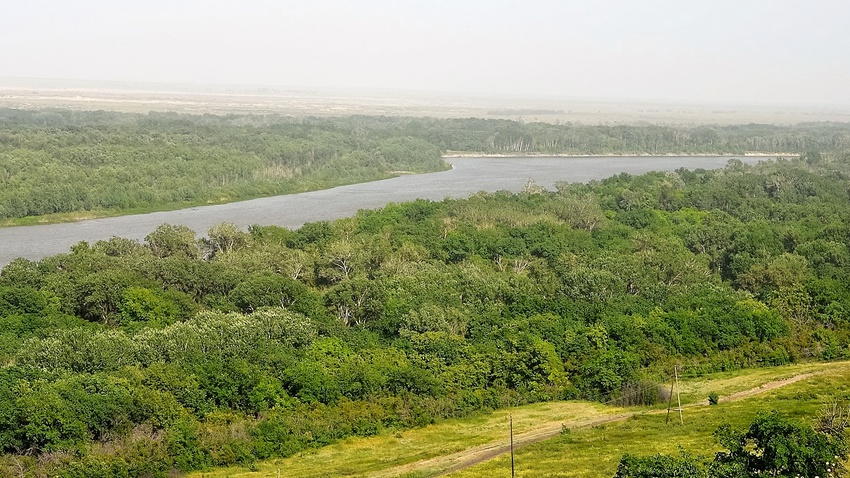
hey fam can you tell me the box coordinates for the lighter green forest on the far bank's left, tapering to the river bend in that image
[0,110,447,219]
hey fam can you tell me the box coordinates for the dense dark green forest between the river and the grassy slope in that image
[0,155,850,477]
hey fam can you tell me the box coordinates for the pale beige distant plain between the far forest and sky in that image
[0,78,850,125]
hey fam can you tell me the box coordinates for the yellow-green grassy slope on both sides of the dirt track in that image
[191,363,850,478]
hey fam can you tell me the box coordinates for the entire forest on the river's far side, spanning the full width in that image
[0,109,850,220]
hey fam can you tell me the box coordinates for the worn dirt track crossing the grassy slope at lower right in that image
[371,371,825,478]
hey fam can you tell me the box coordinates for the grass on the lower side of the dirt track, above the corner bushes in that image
[450,363,850,478]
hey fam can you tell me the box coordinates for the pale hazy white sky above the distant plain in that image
[0,0,850,105]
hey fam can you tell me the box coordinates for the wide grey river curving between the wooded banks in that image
[0,156,758,267]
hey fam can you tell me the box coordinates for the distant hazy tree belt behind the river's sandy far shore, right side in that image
[332,117,850,155]
